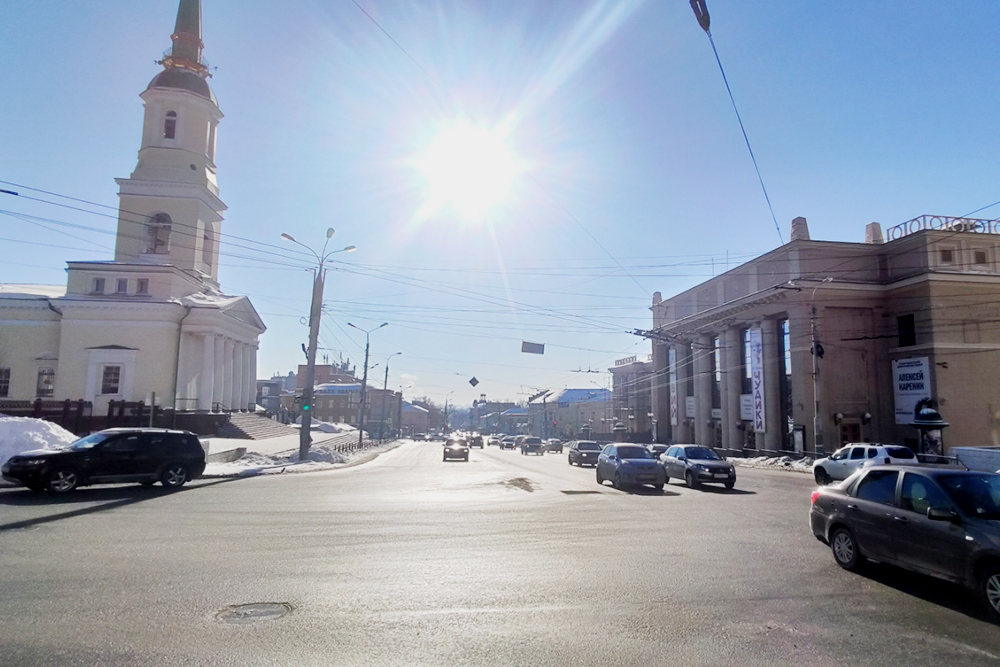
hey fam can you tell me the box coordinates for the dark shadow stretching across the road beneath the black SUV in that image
[0,477,245,532]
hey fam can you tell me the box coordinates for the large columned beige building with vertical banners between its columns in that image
[641,216,1000,453]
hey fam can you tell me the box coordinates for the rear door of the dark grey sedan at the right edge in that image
[846,470,899,560]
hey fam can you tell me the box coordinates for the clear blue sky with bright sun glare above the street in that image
[0,0,1000,404]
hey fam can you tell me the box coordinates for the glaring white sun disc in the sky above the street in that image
[419,123,521,219]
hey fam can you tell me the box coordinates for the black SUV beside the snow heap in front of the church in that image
[0,428,205,493]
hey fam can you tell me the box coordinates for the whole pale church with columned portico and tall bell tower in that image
[0,0,265,415]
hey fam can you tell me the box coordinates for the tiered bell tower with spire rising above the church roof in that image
[115,0,226,289]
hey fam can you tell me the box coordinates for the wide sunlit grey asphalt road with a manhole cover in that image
[0,443,1000,667]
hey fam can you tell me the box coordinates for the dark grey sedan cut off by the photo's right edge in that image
[809,465,1000,621]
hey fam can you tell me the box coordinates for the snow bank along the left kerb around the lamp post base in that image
[202,436,409,477]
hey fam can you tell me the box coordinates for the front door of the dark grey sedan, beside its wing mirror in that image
[893,472,969,580]
